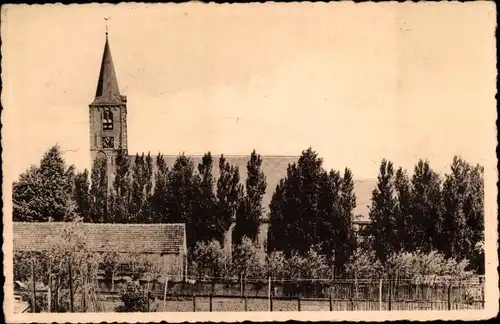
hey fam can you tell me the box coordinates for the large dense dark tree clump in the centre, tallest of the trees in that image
[268,148,356,269]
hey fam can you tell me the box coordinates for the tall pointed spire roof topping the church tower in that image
[92,34,126,105]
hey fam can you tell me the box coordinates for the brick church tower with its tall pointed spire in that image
[89,31,127,185]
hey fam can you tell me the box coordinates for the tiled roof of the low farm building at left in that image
[13,222,186,254]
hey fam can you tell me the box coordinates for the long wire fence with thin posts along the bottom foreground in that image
[18,274,484,312]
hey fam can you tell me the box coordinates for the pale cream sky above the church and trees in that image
[1,2,496,180]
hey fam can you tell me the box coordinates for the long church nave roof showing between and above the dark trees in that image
[130,155,376,220]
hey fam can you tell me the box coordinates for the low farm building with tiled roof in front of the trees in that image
[13,222,187,290]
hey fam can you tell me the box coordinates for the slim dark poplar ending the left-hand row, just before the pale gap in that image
[233,150,267,244]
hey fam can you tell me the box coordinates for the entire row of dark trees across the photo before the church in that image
[13,146,484,274]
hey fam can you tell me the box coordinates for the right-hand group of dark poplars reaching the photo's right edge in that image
[365,157,484,272]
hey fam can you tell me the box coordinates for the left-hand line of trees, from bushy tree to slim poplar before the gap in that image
[13,146,267,246]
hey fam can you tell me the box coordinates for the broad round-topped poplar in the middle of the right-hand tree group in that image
[409,160,443,252]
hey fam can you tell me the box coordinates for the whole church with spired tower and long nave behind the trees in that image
[89,32,374,251]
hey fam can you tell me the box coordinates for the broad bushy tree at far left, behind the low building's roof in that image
[12,145,76,222]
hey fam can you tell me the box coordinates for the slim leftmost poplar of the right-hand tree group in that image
[369,159,399,263]
